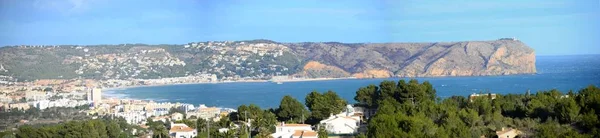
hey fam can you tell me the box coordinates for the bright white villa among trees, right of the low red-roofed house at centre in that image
[319,105,361,135]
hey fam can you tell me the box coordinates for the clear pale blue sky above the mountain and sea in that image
[0,0,600,55]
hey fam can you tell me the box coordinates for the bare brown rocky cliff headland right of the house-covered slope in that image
[290,39,536,78]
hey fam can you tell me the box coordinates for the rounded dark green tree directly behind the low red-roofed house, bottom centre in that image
[277,95,308,123]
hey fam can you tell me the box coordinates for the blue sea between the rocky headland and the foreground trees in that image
[104,55,600,108]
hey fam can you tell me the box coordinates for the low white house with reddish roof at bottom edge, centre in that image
[271,122,318,138]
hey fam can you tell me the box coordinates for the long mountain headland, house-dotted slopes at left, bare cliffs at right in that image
[0,39,536,81]
